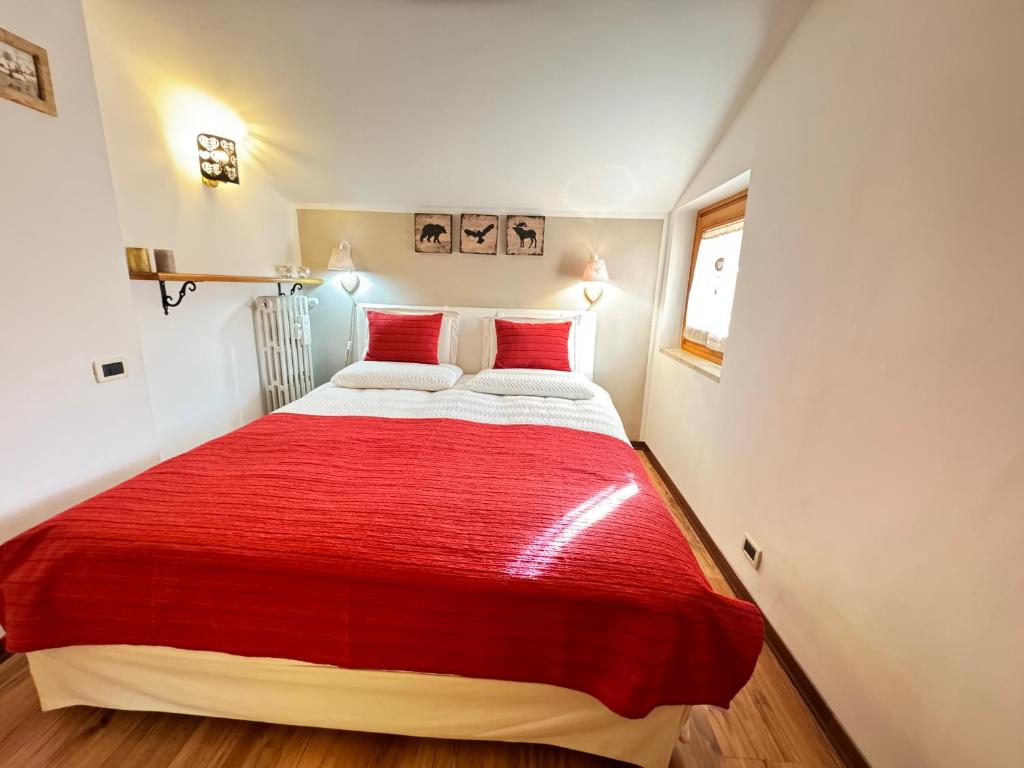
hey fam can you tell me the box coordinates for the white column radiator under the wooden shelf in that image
[253,295,315,413]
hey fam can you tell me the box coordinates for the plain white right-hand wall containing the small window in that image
[645,0,1024,768]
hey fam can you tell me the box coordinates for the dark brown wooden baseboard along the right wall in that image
[633,440,870,768]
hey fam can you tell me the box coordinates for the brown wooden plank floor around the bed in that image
[0,460,842,768]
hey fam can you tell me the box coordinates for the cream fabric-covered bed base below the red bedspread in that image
[27,645,690,768]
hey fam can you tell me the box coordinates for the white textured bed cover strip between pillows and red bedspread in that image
[276,376,629,442]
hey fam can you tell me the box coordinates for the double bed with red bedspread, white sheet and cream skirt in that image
[0,306,763,768]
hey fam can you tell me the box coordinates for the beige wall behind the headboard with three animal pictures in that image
[299,210,664,438]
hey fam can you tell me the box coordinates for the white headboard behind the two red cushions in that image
[352,304,597,379]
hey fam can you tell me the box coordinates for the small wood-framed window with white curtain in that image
[681,191,746,364]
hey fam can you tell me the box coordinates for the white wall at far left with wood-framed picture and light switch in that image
[0,0,157,542]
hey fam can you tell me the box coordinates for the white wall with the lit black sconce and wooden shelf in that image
[86,0,298,457]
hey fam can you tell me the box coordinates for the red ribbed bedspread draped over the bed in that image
[0,414,763,717]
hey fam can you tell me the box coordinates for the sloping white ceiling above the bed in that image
[85,0,810,215]
